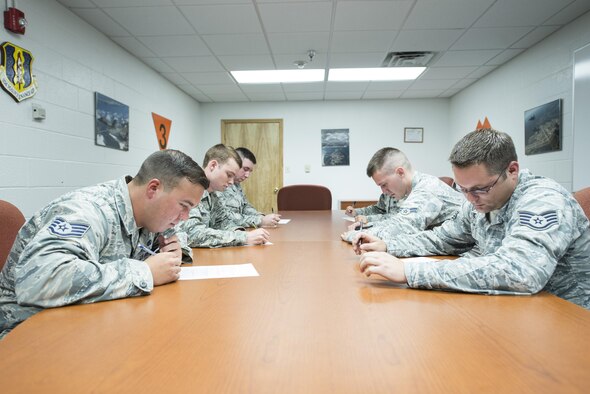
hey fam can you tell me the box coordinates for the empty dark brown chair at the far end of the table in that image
[277,185,332,211]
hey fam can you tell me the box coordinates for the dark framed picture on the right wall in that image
[524,99,562,155]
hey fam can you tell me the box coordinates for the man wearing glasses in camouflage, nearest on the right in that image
[353,129,590,309]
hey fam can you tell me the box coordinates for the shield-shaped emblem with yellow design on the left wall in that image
[0,41,37,102]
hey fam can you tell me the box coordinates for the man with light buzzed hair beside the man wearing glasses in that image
[341,148,465,242]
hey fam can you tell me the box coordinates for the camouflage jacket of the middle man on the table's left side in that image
[178,190,247,248]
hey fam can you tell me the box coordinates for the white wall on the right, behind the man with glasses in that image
[449,13,590,190]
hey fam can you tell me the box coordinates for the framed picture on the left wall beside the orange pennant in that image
[94,92,129,151]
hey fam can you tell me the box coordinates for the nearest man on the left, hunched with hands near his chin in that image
[0,150,209,337]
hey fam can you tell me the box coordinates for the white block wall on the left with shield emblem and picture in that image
[0,0,199,217]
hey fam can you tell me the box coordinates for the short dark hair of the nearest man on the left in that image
[133,149,209,190]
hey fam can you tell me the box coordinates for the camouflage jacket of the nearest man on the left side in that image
[0,177,156,337]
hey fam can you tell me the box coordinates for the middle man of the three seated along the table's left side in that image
[177,144,270,249]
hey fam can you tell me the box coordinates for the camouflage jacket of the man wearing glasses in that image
[388,170,590,308]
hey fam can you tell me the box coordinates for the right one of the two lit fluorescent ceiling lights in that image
[328,67,426,81]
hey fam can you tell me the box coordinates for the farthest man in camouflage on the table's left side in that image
[219,147,281,227]
